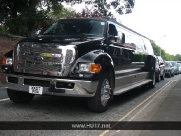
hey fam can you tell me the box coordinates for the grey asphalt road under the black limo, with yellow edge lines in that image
[0,75,181,136]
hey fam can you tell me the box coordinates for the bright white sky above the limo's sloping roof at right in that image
[63,0,181,55]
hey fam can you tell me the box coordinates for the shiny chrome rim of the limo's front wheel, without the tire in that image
[101,79,111,106]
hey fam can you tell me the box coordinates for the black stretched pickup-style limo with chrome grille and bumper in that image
[0,17,155,112]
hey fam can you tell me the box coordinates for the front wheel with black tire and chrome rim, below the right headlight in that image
[88,73,111,113]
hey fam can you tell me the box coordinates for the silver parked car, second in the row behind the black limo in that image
[164,61,174,77]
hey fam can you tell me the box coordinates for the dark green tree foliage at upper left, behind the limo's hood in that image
[0,0,75,36]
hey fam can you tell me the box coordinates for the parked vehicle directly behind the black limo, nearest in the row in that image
[155,56,165,82]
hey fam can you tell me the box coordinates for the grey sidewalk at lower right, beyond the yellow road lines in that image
[139,80,181,136]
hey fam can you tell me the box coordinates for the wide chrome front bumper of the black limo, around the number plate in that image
[0,73,98,97]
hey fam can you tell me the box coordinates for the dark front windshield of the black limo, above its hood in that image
[43,19,105,37]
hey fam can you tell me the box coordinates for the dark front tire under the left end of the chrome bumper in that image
[7,89,35,103]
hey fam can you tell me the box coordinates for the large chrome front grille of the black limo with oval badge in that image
[14,43,75,76]
